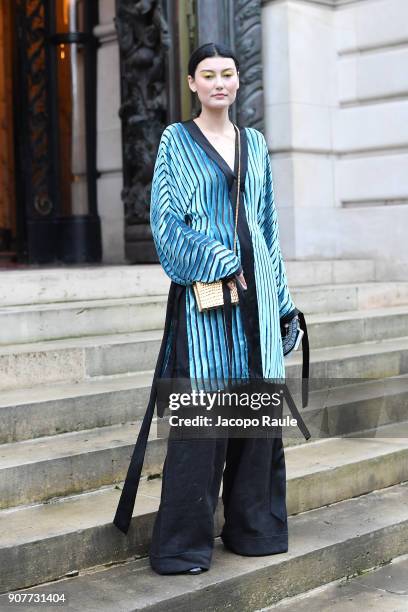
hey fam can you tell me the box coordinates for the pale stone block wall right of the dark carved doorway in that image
[262,0,408,260]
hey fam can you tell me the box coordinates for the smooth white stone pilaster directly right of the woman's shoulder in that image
[262,0,336,259]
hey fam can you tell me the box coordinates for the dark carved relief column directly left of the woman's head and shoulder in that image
[115,0,170,260]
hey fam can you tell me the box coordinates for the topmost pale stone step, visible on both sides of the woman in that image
[0,259,376,306]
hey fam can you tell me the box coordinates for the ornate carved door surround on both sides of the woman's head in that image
[116,0,263,263]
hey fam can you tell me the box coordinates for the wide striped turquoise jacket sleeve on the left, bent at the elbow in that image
[150,127,241,285]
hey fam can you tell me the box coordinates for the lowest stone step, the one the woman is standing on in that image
[6,484,408,612]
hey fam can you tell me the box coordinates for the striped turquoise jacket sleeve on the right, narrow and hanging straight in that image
[258,134,295,318]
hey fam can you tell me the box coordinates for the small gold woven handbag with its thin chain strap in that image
[193,124,241,312]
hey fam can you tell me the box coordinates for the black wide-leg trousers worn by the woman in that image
[150,430,288,574]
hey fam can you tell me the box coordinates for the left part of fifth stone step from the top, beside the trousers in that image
[0,421,166,508]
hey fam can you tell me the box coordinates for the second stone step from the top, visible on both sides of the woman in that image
[0,281,408,346]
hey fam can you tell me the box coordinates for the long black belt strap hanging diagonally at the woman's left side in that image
[113,282,184,534]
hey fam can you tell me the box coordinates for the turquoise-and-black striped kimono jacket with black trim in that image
[113,120,310,533]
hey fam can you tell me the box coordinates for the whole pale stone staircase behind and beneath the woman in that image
[0,260,408,612]
